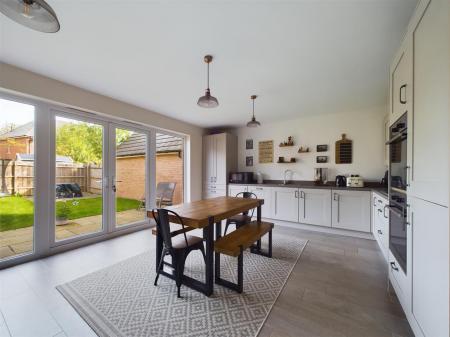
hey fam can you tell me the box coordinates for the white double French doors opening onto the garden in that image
[51,110,152,246]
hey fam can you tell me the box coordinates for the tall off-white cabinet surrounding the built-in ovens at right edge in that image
[389,0,450,337]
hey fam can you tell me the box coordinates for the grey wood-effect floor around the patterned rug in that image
[0,226,413,337]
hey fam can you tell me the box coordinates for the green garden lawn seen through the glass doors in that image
[0,196,140,232]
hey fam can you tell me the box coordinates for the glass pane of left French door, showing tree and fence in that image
[55,117,104,241]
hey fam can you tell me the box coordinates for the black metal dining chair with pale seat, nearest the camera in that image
[152,208,206,297]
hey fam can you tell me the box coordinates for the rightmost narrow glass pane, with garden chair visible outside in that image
[156,133,184,207]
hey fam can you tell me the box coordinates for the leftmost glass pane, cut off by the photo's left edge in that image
[0,99,34,260]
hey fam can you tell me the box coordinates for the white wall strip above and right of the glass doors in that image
[0,62,204,200]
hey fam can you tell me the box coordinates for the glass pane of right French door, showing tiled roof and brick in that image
[115,128,147,226]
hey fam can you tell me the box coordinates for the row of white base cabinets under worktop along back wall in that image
[228,184,371,233]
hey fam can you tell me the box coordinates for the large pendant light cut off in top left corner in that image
[0,0,60,33]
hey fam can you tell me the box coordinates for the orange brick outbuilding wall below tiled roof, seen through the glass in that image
[116,153,183,204]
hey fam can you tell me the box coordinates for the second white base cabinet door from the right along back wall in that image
[298,188,331,227]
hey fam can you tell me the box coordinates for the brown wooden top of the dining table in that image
[147,197,264,228]
